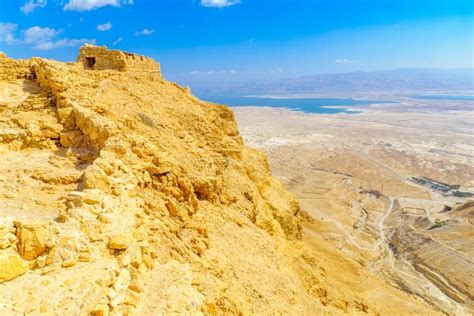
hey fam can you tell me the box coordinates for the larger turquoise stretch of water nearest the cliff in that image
[200,96,391,114]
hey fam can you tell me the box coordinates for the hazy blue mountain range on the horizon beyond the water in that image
[182,68,474,95]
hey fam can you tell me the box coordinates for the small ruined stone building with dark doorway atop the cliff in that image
[77,44,160,74]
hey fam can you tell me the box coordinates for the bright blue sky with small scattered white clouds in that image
[0,0,474,81]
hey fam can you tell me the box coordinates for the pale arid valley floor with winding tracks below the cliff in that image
[234,95,474,315]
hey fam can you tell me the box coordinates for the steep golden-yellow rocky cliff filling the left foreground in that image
[0,46,436,315]
